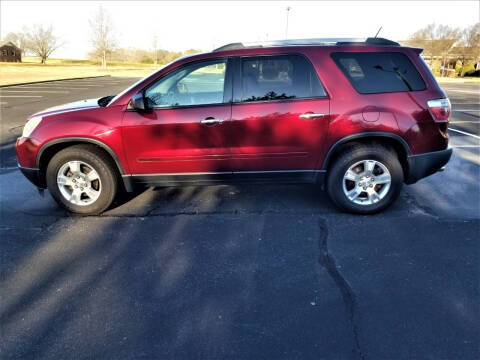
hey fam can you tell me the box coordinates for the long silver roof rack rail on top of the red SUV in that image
[213,38,400,52]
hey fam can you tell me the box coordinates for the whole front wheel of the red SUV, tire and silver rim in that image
[46,145,117,215]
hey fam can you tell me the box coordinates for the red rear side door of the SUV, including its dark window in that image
[231,54,329,177]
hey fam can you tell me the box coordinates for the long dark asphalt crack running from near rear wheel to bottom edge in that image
[318,219,365,360]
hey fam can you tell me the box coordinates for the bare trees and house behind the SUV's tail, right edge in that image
[404,22,480,76]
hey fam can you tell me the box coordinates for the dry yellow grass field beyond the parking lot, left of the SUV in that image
[0,57,161,85]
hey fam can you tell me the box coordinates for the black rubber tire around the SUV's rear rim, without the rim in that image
[327,144,404,214]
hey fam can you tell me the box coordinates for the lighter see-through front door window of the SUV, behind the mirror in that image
[145,60,226,108]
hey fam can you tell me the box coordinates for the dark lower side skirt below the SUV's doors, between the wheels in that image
[122,170,326,191]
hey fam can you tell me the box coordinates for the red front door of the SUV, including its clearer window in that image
[122,59,231,174]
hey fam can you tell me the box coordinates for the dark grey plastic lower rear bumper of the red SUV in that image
[405,148,452,184]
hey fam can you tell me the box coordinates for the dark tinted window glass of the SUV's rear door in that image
[242,55,326,101]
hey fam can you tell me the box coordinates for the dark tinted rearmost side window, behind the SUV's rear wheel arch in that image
[332,52,425,94]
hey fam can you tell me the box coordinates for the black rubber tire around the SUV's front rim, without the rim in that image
[46,144,118,215]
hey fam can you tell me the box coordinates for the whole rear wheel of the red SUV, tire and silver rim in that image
[327,144,403,214]
